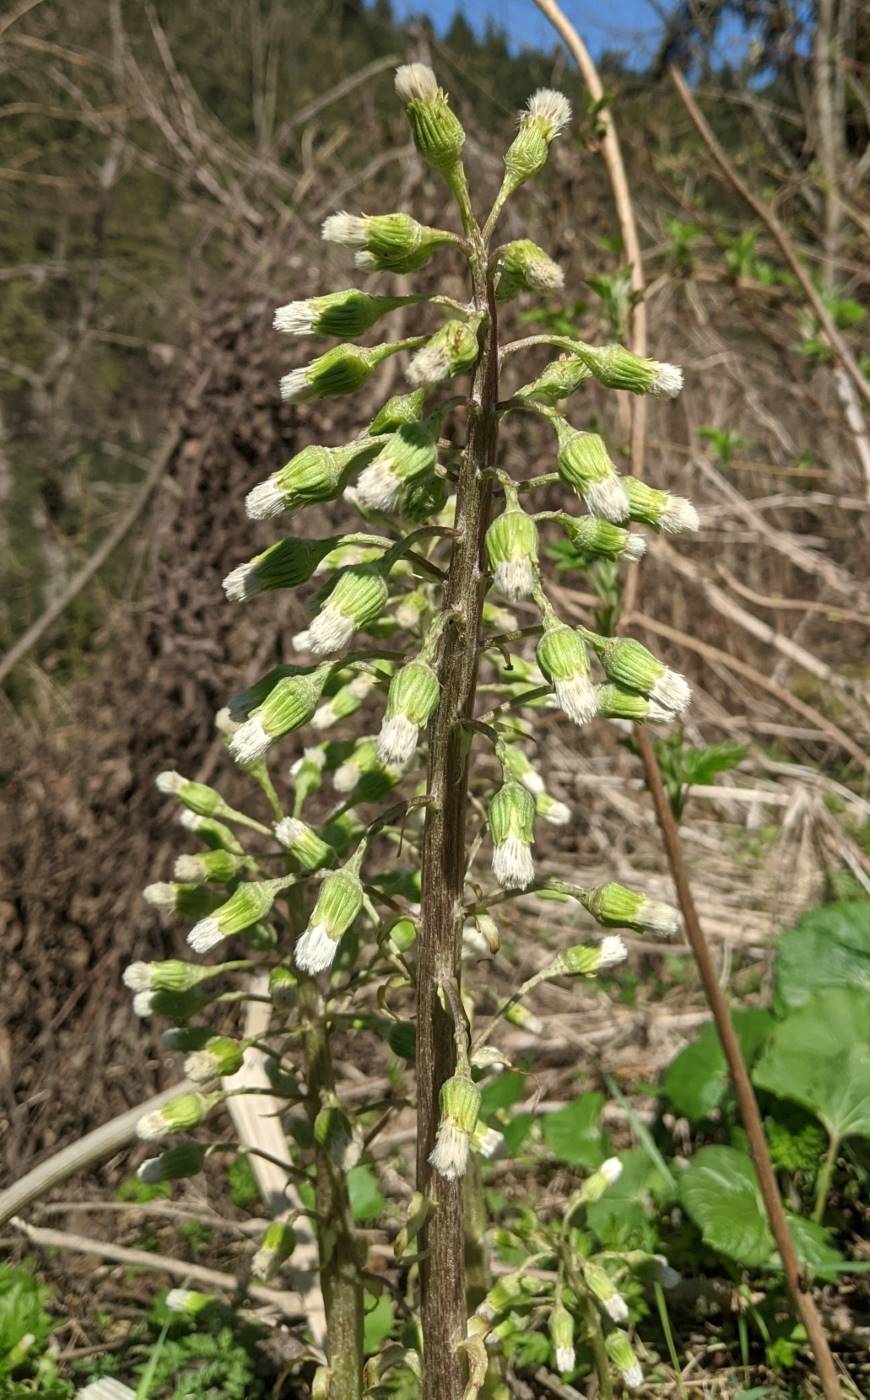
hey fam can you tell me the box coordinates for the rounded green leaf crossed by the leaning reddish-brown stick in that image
[679,1147,842,1273]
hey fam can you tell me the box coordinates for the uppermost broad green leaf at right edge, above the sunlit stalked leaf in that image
[773,899,870,1009]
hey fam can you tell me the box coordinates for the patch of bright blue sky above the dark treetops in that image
[378,0,667,67]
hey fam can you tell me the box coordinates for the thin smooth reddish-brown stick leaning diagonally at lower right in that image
[635,725,842,1400]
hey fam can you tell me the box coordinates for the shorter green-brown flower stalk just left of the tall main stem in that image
[300,981,363,1400]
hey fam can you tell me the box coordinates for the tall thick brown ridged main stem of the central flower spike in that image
[416,246,499,1400]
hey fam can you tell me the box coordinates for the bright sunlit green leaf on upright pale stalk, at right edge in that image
[754,987,870,1140]
